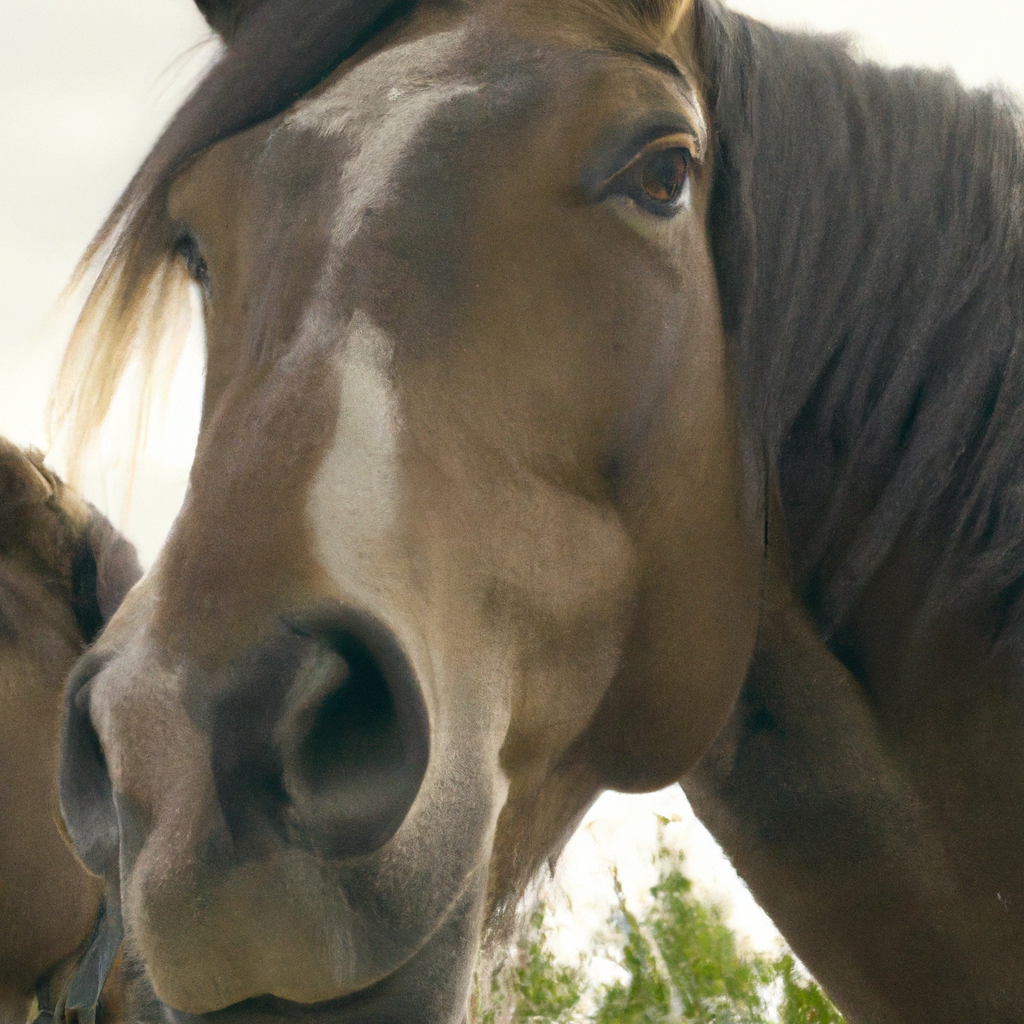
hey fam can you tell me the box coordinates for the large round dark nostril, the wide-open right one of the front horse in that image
[274,607,430,857]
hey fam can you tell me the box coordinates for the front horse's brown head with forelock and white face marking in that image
[54,0,763,1024]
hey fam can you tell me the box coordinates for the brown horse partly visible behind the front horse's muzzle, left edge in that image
[0,438,140,1024]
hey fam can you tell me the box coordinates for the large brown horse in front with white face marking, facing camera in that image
[54,0,1024,1024]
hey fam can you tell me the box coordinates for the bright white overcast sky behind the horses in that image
[0,0,1024,966]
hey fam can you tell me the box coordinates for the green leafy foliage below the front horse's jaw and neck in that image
[476,831,844,1024]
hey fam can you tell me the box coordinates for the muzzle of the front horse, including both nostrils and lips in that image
[60,602,492,1021]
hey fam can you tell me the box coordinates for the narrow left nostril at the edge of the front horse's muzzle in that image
[57,654,119,874]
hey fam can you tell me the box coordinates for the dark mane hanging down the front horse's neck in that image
[701,0,1024,655]
